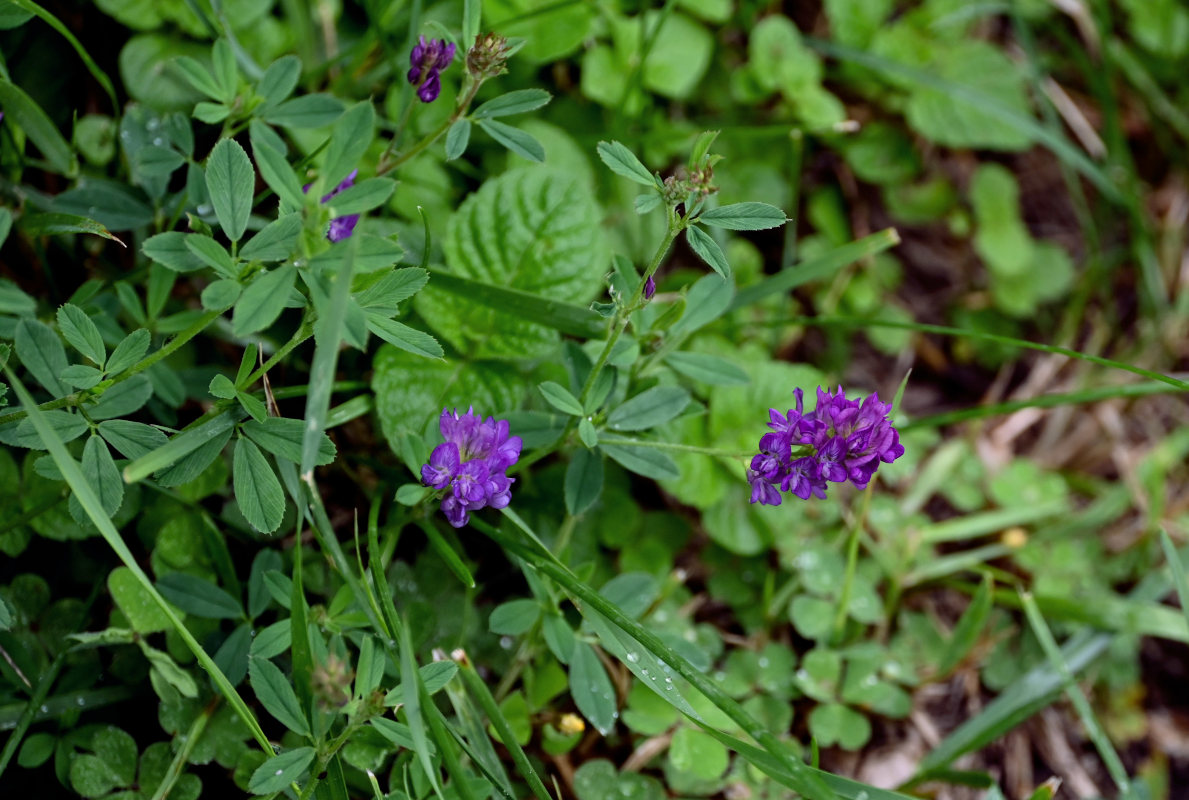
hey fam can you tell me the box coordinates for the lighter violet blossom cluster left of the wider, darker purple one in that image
[421,408,522,528]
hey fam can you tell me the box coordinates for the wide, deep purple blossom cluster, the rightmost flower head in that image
[747,386,904,505]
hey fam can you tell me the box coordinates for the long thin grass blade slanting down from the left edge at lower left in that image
[5,367,273,756]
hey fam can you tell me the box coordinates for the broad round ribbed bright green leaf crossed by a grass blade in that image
[414,169,610,359]
